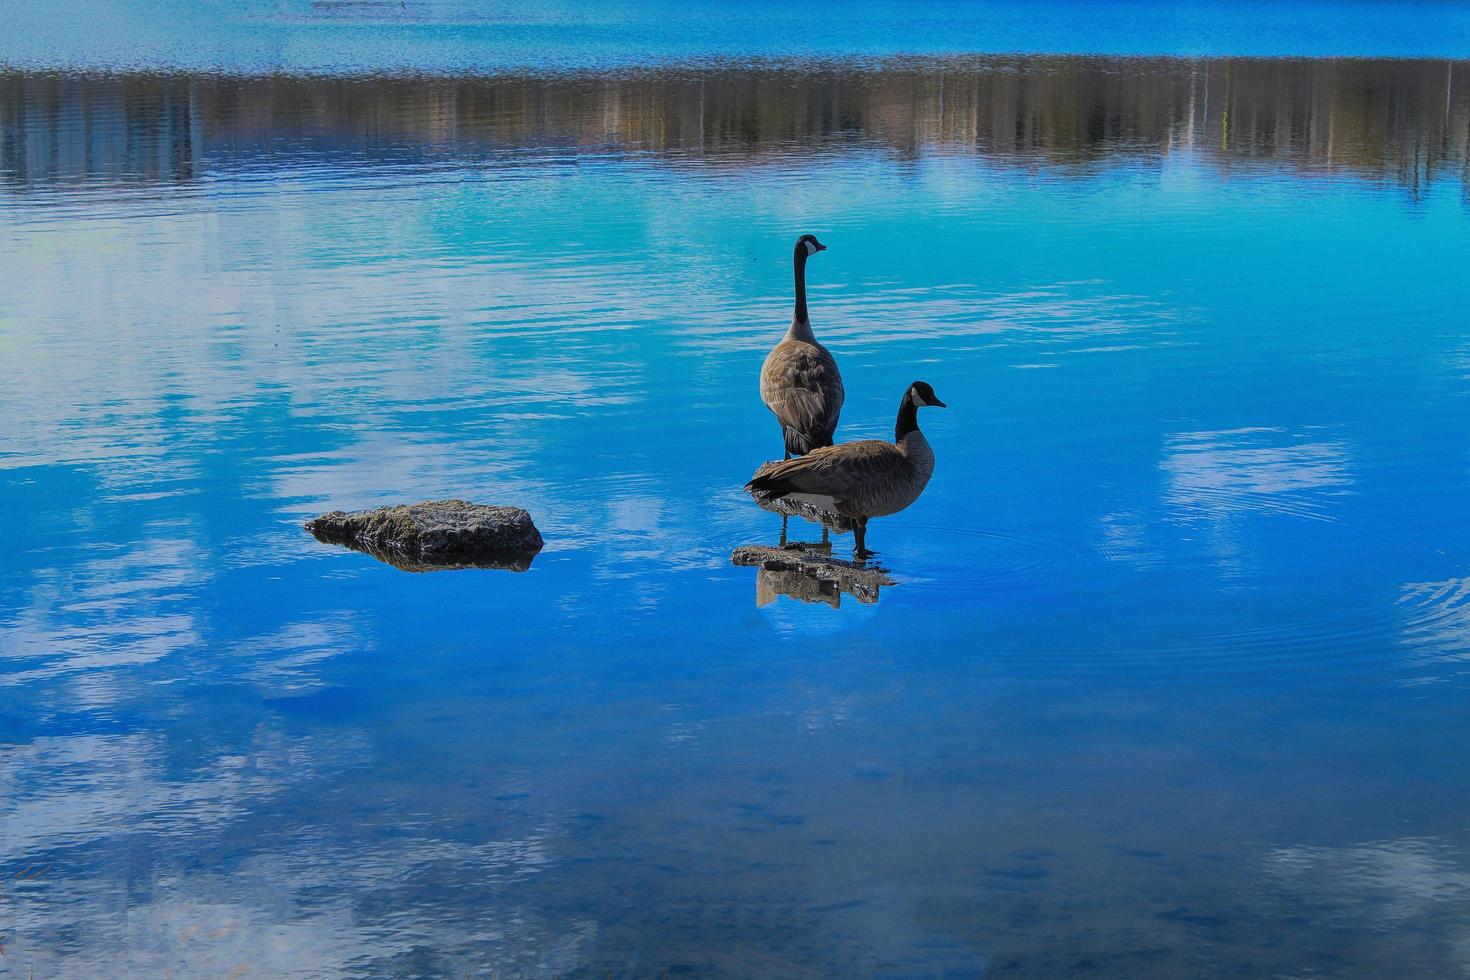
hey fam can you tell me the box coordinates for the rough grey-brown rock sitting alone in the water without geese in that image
[304,500,542,572]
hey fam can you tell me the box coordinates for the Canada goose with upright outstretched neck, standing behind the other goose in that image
[760,235,844,460]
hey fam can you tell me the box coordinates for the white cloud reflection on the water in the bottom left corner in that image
[0,727,597,977]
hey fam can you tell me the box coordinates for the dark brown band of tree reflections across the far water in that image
[0,57,1470,192]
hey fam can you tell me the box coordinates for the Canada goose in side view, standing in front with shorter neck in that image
[745,381,945,558]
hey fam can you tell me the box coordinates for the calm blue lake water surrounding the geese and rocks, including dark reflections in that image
[0,4,1470,977]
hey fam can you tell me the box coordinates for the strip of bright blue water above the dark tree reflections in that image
[0,0,1470,73]
